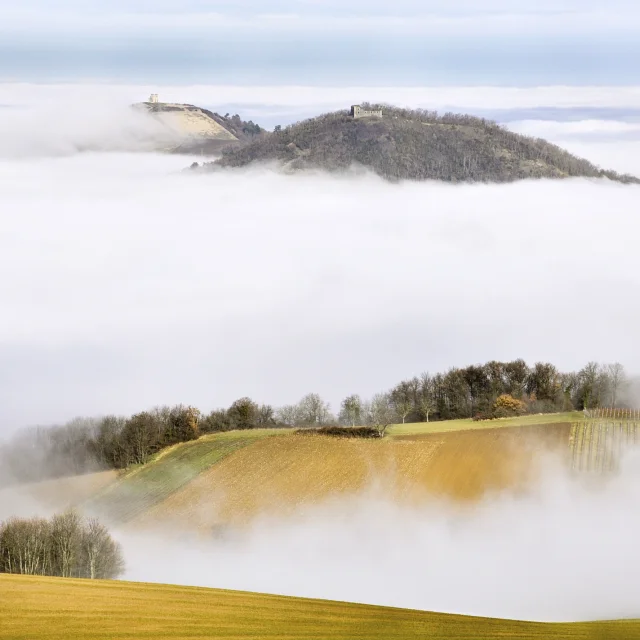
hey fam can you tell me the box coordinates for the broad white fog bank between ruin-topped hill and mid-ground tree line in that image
[0,154,640,432]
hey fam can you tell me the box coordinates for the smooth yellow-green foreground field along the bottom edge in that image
[0,575,640,640]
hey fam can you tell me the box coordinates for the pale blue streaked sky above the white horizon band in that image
[0,0,640,85]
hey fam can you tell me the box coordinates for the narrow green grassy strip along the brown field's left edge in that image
[82,429,279,524]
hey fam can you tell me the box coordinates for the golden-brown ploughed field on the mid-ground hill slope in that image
[131,423,571,531]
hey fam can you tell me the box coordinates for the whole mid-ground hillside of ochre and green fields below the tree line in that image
[0,414,577,531]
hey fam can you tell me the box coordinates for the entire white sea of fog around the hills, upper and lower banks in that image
[0,84,640,620]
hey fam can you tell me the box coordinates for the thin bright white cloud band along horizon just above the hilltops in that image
[6,82,640,111]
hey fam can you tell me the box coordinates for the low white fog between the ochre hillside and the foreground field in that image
[121,452,640,621]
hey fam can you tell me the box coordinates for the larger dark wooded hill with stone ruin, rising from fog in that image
[205,104,640,184]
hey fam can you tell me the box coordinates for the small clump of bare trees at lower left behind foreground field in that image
[0,511,125,579]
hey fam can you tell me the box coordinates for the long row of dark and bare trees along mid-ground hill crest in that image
[0,360,628,486]
